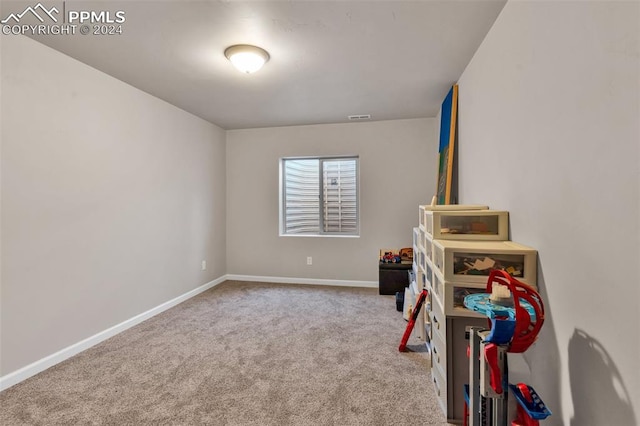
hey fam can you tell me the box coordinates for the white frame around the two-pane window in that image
[278,155,360,238]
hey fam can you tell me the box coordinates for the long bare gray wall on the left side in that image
[0,36,226,375]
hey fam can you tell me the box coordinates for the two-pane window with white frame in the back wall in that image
[280,157,358,235]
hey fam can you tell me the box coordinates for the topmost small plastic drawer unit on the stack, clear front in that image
[424,210,509,241]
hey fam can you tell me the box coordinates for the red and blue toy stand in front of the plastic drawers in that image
[464,270,551,426]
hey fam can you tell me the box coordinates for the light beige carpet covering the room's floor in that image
[0,281,447,426]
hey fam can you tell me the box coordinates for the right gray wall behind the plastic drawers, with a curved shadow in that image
[459,2,640,426]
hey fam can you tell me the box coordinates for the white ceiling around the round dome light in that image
[2,0,506,129]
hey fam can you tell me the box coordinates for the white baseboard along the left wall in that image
[0,275,228,391]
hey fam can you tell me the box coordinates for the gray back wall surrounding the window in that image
[227,119,438,281]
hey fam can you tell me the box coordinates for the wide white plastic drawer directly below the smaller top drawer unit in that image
[433,239,537,286]
